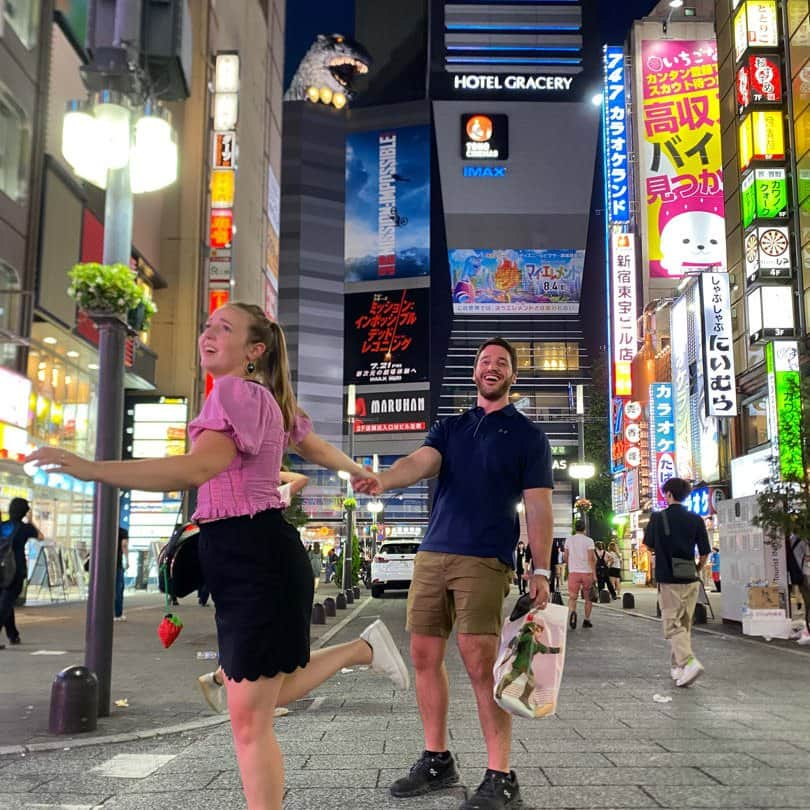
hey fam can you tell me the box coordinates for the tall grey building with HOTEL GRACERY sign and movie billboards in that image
[344,0,599,534]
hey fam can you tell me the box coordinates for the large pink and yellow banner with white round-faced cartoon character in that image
[641,40,726,278]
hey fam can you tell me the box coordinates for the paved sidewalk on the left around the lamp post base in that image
[0,585,360,748]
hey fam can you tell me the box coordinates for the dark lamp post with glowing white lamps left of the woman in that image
[62,83,177,717]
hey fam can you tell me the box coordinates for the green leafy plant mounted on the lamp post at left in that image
[68,262,157,331]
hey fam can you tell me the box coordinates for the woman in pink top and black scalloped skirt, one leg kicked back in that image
[29,303,408,810]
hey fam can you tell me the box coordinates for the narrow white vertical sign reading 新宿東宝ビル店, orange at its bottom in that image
[610,233,638,396]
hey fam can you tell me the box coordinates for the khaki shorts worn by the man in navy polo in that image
[406,551,515,638]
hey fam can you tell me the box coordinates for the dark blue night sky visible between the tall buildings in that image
[284,0,656,89]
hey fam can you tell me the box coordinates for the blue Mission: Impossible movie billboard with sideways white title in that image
[345,126,430,282]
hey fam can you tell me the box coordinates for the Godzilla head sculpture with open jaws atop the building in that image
[284,34,371,101]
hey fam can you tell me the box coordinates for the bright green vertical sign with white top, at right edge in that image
[765,340,804,479]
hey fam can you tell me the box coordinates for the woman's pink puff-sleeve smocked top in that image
[188,377,312,520]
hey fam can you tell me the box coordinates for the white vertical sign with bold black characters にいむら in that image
[700,272,737,416]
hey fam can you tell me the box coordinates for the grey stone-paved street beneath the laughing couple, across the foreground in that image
[0,596,810,810]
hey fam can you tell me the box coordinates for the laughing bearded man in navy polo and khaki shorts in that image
[356,338,554,810]
